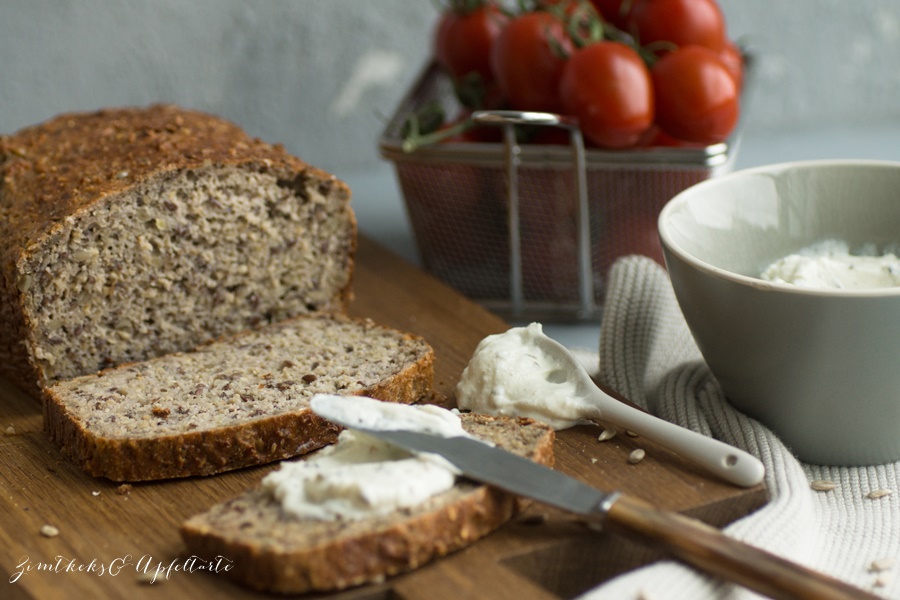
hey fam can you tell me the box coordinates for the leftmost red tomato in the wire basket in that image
[434,2,509,84]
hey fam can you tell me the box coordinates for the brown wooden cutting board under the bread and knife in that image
[0,238,767,600]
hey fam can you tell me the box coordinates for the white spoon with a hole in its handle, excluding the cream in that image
[534,335,765,487]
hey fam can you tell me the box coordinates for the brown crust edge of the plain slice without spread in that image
[44,315,434,481]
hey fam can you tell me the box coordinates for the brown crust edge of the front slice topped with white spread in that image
[180,414,555,594]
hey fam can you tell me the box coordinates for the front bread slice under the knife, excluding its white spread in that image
[181,414,554,594]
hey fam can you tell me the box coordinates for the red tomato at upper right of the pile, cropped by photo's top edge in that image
[628,0,726,51]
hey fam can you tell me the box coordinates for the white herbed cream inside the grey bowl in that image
[761,240,900,290]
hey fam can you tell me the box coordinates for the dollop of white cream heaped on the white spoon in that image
[456,323,600,429]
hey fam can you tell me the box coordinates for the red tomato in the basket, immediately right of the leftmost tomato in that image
[491,12,574,113]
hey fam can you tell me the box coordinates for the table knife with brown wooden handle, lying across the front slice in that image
[352,424,878,600]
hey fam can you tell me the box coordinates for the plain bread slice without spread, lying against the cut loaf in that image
[44,315,434,481]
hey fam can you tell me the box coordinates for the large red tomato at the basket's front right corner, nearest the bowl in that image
[652,46,740,144]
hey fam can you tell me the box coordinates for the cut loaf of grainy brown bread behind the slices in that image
[0,105,356,396]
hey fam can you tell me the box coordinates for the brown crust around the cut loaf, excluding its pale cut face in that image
[0,104,356,398]
